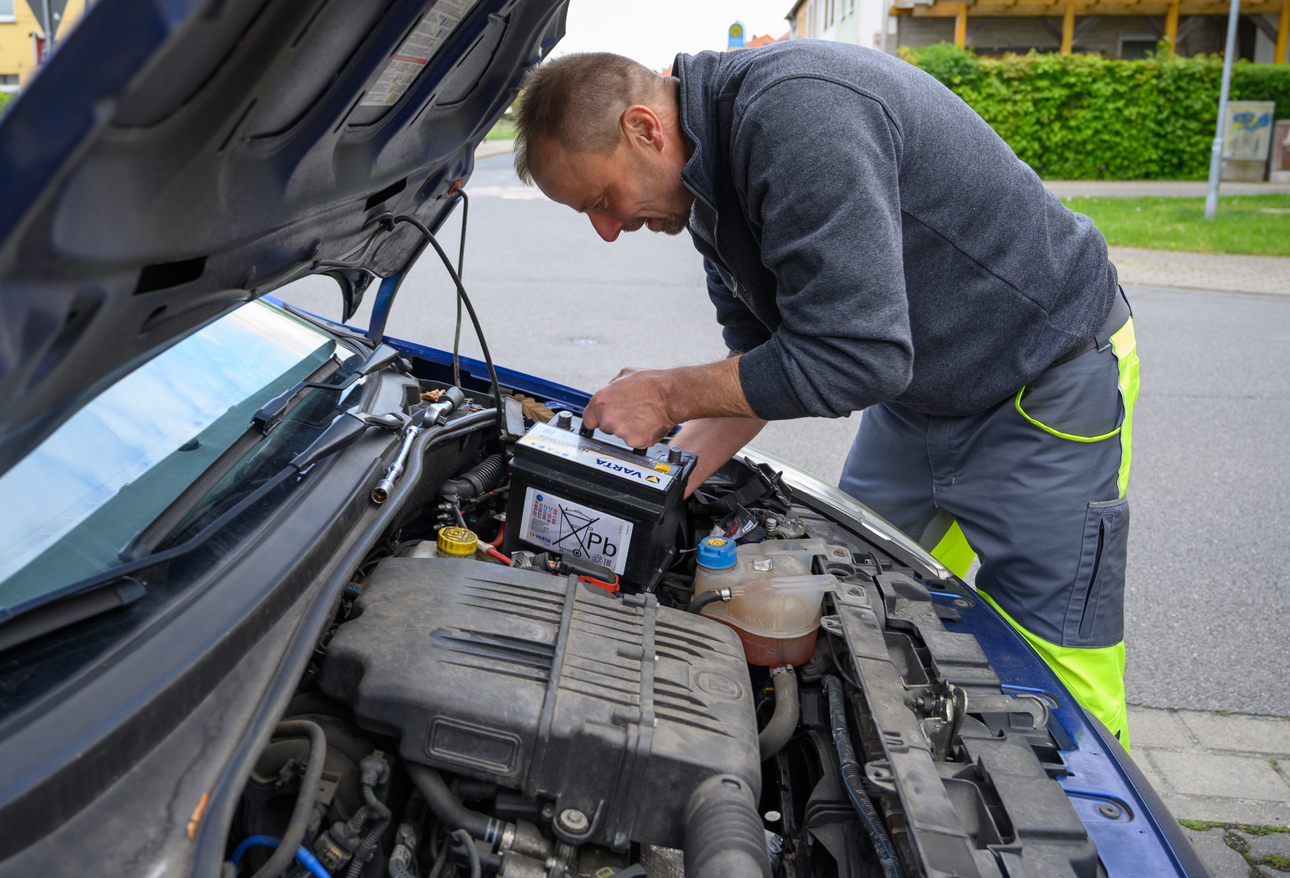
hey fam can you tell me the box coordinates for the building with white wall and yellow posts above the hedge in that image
[787,0,1290,63]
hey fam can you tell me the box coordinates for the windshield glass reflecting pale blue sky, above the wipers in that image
[0,302,353,607]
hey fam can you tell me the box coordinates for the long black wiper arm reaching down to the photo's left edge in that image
[0,411,412,650]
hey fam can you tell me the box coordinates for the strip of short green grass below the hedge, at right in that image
[1062,195,1290,257]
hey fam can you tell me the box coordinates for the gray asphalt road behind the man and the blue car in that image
[281,156,1290,716]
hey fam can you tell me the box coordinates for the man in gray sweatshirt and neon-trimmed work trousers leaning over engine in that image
[515,40,1138,745]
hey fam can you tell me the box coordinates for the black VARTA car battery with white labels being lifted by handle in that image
[503,413,697,592]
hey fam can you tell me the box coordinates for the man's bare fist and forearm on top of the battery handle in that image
[582,357,755,449]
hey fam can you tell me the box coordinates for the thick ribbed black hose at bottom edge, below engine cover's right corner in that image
[684,775,770,878]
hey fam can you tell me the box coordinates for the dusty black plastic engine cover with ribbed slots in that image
[321,558,761,850]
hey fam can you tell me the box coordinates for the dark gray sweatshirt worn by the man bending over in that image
[672,40,1116,419]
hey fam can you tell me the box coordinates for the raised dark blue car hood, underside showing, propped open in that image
[0,0,566,472]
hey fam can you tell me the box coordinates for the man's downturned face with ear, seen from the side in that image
[533,143,694,241]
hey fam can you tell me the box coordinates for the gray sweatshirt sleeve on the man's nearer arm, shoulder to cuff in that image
[731,77,913,420]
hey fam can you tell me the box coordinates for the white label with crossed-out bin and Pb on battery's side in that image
[520,487,632,575]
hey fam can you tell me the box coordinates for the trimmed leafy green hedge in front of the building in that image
[902,43,1290,179]
